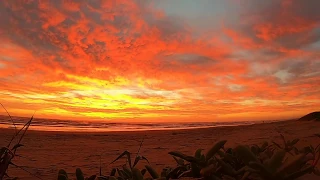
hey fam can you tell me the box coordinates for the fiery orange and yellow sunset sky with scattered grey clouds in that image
[0,0,320,122]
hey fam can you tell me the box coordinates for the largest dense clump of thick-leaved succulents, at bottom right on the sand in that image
[166,135,320,180]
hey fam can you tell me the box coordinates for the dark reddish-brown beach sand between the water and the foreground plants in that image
[0,121,320,180]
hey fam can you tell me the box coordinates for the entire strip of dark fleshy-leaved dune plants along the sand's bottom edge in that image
[58,134,320,180]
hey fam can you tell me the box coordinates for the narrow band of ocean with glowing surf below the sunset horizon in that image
[0,116,278,132]
